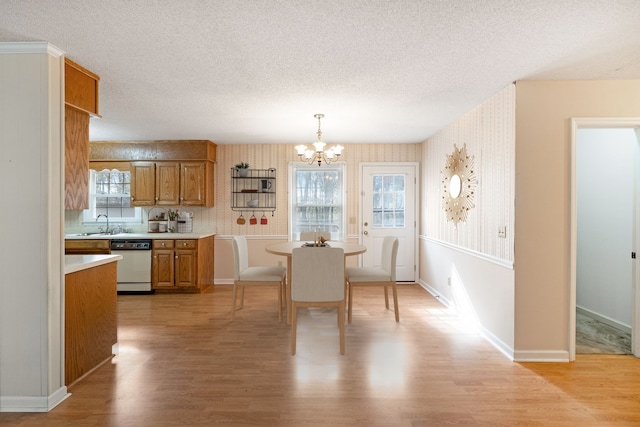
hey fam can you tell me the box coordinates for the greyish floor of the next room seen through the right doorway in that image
[576,313,631,354]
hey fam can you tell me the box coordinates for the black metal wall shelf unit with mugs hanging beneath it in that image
[231,168,276,216]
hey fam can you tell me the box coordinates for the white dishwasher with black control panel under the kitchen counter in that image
[111,239,153,293]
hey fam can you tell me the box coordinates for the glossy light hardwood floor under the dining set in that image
[0,285,640,427]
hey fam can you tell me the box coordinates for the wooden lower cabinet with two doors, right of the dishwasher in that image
[151,236,213,292]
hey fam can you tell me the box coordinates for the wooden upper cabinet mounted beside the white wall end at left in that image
[64,58,100,210]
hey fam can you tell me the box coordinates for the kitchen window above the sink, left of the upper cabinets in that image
[83,169,142,223]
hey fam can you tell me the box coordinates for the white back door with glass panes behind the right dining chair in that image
[358,162,418,282]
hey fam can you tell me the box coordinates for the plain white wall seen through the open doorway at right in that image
[576,129,638,328]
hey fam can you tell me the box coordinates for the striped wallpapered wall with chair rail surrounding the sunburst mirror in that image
[420,85,515,357]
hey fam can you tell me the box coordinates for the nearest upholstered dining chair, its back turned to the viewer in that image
[291,247,345,354]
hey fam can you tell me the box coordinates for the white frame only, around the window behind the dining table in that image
[288,162,347,241]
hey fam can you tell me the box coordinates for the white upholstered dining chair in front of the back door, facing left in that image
[345,236,400,323]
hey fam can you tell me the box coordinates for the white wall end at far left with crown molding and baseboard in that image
[0,43,67,412]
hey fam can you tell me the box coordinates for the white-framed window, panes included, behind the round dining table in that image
[289,163,346,240]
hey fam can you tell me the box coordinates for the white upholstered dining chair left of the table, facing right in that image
[231,236,287,321]
